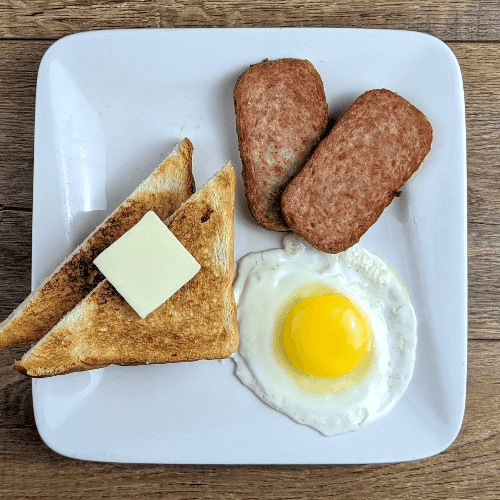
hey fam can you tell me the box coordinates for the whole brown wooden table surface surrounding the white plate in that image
[0,0,500,499]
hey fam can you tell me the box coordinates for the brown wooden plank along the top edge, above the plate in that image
[0,0,500,41]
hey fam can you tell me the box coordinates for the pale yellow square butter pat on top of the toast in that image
[94,212,201,318]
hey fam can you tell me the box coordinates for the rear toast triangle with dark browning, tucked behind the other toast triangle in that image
[0,139,194,348]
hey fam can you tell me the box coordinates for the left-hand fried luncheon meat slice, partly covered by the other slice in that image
[234,59,328,231]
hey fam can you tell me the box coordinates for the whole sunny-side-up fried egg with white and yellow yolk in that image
[232,234,417,436]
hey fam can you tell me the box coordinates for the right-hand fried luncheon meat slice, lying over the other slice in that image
[281,89,432,253]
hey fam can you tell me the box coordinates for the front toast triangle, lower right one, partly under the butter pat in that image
[14,163,238,377]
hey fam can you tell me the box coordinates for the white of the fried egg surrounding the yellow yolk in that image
[232,234,417,436]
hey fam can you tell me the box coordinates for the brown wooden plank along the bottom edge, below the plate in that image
[0,341,500,499]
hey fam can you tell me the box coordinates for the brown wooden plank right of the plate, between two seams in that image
[449,43,500,339]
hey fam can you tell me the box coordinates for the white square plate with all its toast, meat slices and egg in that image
[0,28,467,464]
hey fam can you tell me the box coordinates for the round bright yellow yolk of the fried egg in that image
[281,294,371,377]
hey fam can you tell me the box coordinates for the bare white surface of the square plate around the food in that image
[32,28,467,464]
